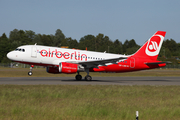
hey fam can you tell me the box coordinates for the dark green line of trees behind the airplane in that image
[0,29,180,63]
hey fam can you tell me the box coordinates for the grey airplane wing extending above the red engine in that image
[71,57,127,68]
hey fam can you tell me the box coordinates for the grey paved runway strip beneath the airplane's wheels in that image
[0,77,180,85]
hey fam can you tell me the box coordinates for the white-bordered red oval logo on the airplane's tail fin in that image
[146,35,164,56]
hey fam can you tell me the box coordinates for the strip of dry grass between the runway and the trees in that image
[0,68,180,77]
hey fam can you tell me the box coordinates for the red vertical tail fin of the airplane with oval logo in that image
[133,31,166,60]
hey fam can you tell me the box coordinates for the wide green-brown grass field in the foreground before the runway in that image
[0,85,180,120]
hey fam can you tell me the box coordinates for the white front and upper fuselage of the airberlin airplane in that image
[7,45,127,65]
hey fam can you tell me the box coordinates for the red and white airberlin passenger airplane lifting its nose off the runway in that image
[7,31,166,81]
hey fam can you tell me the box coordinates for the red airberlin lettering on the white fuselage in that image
[40,48,87,61]
